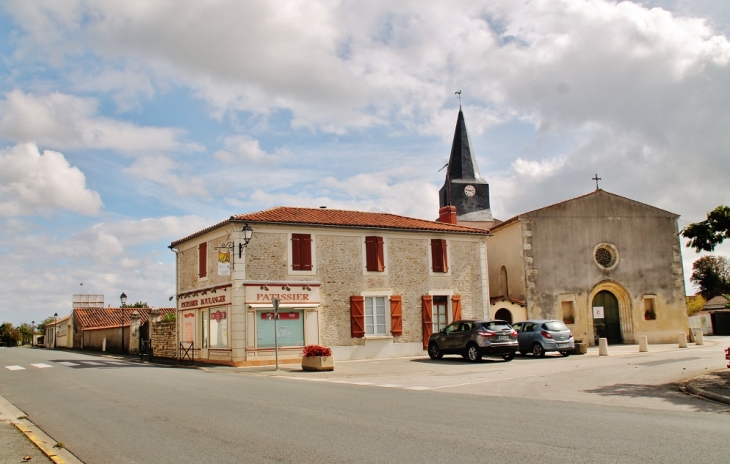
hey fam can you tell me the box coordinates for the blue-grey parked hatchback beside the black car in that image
[512,320,575,358]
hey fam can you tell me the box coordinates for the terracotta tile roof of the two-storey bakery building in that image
[170,206,487,247]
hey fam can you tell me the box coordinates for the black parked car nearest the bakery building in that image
[428,320,518,362]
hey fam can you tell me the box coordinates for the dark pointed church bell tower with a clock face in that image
[439,106,494,223]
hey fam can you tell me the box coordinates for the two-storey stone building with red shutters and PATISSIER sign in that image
[170,207,489,365]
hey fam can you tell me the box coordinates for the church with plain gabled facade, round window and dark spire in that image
[439,108,688,345]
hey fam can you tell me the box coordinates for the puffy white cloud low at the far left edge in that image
[0,143,102,217]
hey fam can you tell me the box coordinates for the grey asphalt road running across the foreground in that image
[0,338,730,464]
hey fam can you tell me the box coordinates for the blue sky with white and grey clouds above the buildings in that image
[0,0,730,325]
